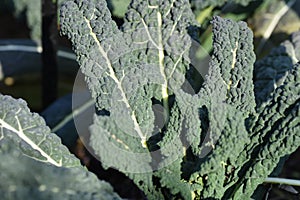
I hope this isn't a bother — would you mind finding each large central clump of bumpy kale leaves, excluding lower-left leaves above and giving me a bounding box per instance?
[60,0,300,199]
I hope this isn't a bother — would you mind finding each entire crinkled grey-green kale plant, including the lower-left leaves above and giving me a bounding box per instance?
[0,0,300,199]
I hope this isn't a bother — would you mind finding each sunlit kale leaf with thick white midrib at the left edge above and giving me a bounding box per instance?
[0,94,80,167]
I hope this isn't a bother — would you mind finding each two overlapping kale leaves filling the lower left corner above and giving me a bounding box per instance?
[0,94,120,200]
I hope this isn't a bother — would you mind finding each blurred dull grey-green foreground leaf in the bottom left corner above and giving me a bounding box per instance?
[0,138,121,200]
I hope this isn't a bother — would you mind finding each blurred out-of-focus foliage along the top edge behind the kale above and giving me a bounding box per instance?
[0,0,300,52]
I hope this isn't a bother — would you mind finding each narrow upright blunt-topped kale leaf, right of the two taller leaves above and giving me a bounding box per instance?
[208,17,255,117]
